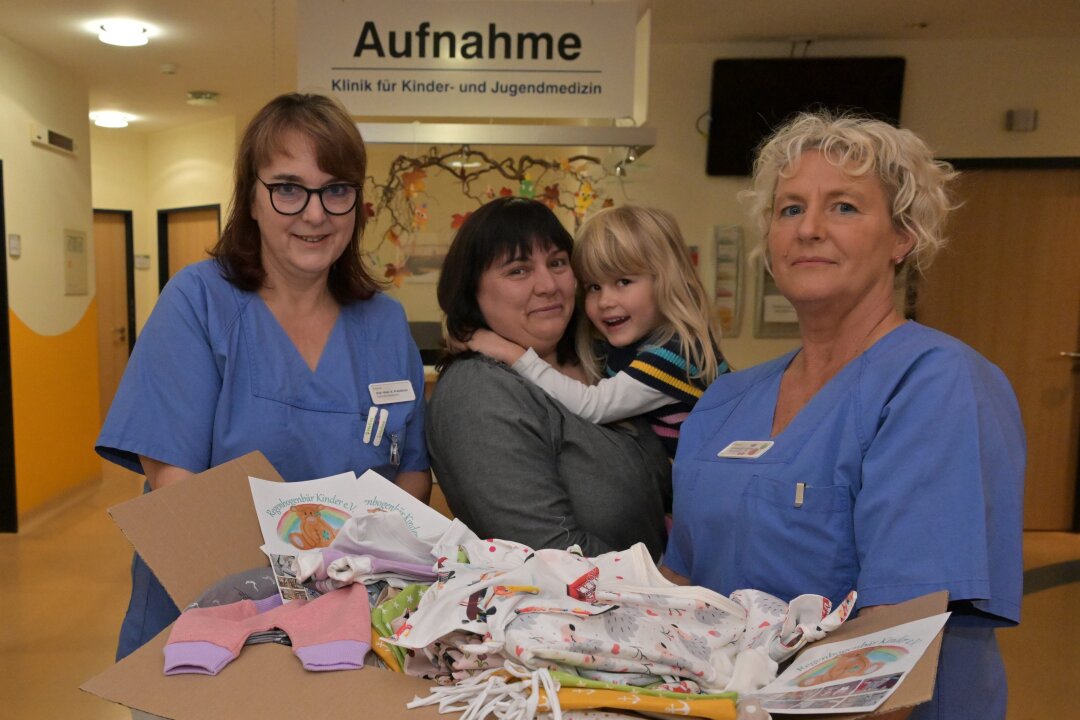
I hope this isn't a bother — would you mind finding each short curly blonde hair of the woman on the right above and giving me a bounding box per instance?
[740,111,958,272]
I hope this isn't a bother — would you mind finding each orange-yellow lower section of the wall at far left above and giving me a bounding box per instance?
[9,300,102,518]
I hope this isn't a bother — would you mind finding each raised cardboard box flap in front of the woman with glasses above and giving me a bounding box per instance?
[109,452,282,608]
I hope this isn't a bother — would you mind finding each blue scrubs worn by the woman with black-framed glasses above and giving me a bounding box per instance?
[96,260,429,657]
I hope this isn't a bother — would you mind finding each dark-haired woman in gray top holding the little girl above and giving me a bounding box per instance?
[427,198,671,557]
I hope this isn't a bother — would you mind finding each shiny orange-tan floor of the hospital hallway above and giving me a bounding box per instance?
[0,466,1080,720]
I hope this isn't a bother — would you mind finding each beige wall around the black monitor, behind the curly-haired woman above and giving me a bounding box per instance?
[630,39,1080,367]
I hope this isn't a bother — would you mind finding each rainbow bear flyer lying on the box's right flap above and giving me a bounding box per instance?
[757,612,949,715]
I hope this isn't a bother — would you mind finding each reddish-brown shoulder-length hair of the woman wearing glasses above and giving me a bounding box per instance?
[211,93,380,304]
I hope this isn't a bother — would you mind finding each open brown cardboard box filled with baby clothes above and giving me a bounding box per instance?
[81,452,946,720]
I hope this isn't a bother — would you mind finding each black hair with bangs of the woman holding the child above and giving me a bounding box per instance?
[437,198,578,370]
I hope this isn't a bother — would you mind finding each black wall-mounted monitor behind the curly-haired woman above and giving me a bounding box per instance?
[705,57,904,175]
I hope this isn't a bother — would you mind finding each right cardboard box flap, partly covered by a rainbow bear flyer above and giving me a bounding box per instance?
[772,590,948,720]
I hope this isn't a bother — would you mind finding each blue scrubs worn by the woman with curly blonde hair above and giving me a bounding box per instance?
[664,323,1026,718]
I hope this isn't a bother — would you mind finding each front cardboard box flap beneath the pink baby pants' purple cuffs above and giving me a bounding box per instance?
[81,621,447,720]
